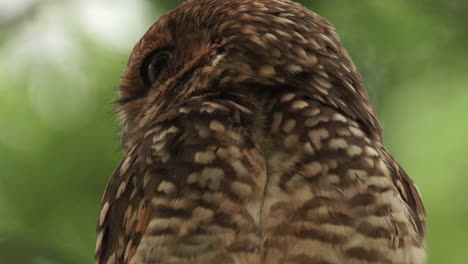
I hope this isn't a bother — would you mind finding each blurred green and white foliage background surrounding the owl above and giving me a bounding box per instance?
[0,0,468,264]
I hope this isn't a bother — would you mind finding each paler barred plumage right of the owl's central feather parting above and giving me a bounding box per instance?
[247,93,425,264]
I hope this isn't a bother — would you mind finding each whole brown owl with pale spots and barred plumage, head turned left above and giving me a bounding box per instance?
[96,0,426,264]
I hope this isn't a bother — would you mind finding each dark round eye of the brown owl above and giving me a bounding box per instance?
[141,51,171,85]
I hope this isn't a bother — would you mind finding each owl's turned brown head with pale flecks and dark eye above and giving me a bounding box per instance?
[117,0,379,152]
